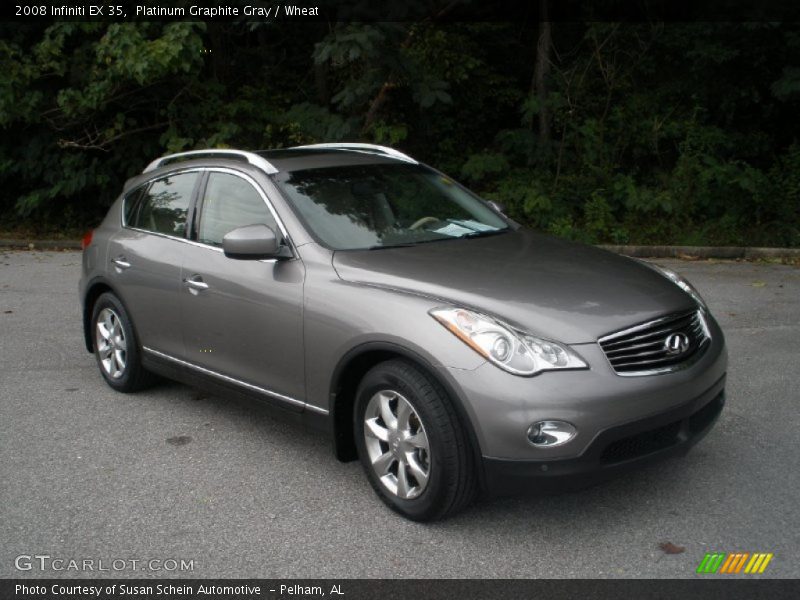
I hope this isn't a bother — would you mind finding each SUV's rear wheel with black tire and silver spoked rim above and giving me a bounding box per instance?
[91,292,156,392]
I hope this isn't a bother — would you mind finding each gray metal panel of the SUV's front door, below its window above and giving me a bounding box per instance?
[179,238,305,399]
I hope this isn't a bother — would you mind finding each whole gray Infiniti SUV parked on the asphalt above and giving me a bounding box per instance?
[80,144,727,521]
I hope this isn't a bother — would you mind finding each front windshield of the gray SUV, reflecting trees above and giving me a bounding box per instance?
[276,163,508,250]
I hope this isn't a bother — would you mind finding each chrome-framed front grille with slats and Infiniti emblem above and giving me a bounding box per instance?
[599,310,709,375]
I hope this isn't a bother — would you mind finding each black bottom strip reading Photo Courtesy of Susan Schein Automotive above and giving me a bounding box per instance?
[0,576,800,600]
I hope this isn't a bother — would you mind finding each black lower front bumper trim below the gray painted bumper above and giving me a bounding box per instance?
[483,377,725,495]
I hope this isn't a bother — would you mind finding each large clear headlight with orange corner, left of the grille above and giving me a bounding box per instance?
[430,308,588,375]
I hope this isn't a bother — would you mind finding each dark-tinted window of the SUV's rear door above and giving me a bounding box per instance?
[126,173,198,237]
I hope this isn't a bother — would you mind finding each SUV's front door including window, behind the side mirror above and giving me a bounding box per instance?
[180,169,305,410]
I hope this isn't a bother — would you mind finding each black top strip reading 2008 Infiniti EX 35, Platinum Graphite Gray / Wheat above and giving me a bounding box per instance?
[0,0,800,23]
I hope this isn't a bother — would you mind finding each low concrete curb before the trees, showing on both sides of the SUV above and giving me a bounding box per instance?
[0,239,800,260]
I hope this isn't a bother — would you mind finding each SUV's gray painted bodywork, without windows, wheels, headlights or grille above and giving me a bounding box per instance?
[80,152,727,459]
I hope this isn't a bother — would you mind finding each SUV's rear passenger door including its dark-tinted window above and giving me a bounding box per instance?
[107,171,200,357]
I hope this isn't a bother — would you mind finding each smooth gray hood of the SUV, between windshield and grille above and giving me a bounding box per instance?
[333,229,695,344]
